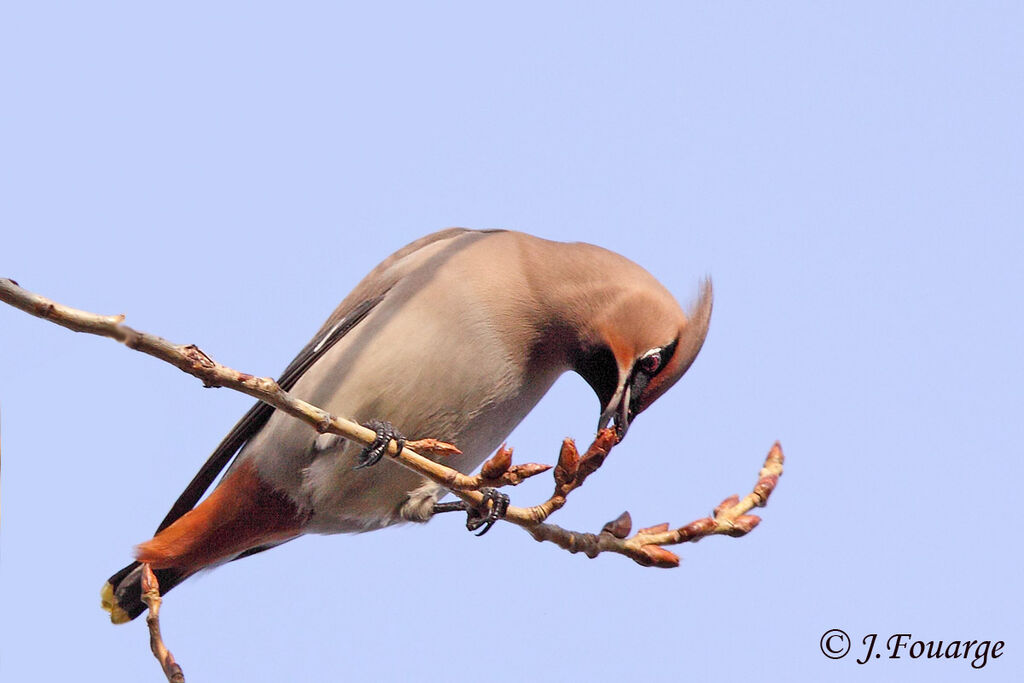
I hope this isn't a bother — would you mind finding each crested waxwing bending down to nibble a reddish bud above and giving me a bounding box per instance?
[101,228,713,624]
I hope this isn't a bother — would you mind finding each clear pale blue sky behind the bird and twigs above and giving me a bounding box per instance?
[0,2,1024,682]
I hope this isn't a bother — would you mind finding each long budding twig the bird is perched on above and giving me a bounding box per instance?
[0,279,782,567]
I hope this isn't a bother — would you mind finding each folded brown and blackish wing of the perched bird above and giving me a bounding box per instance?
[157,227,490,532]
